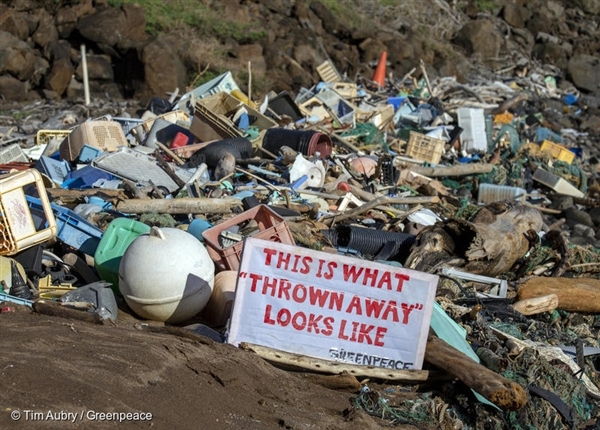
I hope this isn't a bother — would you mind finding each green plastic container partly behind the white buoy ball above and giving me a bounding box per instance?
[94,218,150,295]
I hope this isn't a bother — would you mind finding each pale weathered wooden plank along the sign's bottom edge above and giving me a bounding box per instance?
[240,342,429,382]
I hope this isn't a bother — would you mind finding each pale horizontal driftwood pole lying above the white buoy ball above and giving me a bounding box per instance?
[116,197,242,215]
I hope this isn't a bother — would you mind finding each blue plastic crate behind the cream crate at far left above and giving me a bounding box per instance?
[26,196,104,255]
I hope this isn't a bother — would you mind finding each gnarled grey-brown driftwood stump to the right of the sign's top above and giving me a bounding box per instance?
[405,204,543,276]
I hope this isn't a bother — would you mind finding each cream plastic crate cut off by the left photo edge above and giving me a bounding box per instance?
[0,169,57,255]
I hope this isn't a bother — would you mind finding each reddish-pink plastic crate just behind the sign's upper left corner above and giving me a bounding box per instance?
[202,205,296,270]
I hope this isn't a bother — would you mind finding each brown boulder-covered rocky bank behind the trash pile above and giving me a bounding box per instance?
[0,0,600,101]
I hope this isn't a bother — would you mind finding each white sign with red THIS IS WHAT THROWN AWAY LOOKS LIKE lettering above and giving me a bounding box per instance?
[227,238,438,369]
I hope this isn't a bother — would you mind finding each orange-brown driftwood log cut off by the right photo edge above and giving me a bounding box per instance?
[517,276,600,313]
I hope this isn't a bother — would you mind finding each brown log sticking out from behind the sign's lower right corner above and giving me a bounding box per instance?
[425,334,527,411]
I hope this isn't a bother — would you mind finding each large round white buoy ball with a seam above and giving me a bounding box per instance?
[119,227,215,323]
